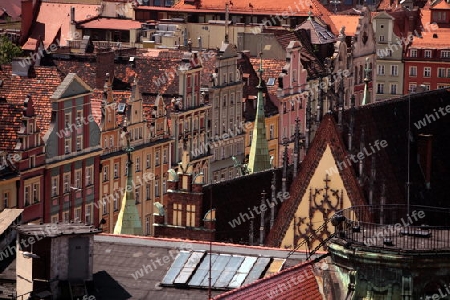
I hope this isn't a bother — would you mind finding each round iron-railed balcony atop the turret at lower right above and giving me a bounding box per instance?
[331,205,450,252]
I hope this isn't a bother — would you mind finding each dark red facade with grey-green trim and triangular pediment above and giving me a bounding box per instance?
[43,73,101,225]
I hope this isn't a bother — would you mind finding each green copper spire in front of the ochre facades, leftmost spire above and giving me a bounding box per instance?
[114,127,142,235]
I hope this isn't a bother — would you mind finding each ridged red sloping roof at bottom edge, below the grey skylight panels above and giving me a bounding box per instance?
[213,261,323,300]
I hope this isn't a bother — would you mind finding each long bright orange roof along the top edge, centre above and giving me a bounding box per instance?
[173,0,323,16]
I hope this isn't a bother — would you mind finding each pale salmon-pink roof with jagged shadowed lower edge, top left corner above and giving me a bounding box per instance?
[22,2,101,50]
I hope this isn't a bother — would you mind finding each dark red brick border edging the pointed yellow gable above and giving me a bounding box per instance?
[266,115,366,247]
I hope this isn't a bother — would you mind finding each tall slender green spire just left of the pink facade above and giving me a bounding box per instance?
[248,48,271,173]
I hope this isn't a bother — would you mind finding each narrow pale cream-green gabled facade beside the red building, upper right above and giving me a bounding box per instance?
[372,12,404,100]
